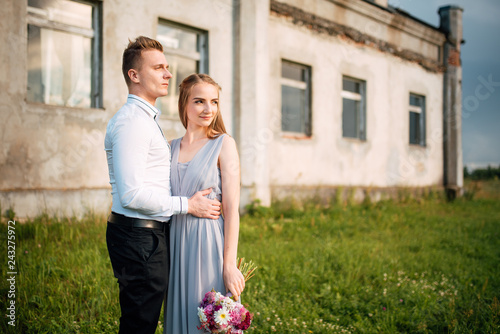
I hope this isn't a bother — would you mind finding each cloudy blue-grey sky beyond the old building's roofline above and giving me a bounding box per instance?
[389,0,500,170]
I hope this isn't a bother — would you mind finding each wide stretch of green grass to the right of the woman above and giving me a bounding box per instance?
[240,194,500,333]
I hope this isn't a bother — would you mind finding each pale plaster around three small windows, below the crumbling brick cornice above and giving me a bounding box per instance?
[269,17,443,187]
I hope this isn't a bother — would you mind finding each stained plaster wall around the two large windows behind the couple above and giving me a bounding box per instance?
[0,0,233,217]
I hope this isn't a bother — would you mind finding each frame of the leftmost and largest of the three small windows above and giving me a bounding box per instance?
[280,59,312,138]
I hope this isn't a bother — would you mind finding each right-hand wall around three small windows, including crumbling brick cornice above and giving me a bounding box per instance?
[269,0,444,197]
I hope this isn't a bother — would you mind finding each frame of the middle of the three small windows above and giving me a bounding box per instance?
[340,75,367,141]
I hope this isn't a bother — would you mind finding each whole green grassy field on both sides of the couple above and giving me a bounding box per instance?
[0,181,500,333]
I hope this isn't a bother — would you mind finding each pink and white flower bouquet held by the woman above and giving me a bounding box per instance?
[198,259,257,334]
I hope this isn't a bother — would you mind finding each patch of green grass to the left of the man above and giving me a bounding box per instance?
[0,215,119,333]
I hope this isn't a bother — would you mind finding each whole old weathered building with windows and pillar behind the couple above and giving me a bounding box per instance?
[0,0,462,217]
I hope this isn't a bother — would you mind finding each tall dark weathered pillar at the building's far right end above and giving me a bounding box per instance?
[438,6,463,200]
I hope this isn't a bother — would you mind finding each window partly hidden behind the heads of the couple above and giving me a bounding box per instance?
[156,20,208,118]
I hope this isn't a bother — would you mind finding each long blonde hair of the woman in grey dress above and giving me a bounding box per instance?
[179,73,227,139]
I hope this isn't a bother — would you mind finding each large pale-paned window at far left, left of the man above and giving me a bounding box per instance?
[27,0,102,108]
